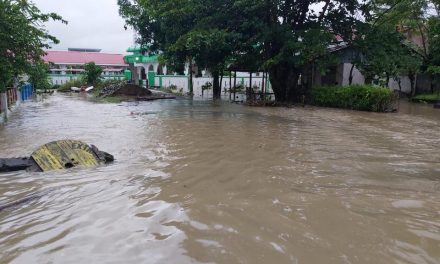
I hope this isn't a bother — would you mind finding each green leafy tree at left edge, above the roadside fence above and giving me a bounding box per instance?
[0,0,67,91]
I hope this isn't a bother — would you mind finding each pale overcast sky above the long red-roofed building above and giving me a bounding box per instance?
[32,0,133,53]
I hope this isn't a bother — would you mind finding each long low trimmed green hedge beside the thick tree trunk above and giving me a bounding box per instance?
[310,85,396,112]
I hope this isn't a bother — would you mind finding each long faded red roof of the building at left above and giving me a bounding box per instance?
[43,50,125,65]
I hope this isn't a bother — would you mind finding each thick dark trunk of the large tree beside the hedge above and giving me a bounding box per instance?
[269,64,301,103]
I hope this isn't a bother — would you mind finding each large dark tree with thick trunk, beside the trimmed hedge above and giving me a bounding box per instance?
[256,0,360,101]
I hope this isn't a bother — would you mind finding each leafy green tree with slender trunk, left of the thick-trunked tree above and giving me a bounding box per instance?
[118,0,241,99]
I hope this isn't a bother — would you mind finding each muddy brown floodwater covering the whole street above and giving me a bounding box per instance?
[0,95,440,264]
